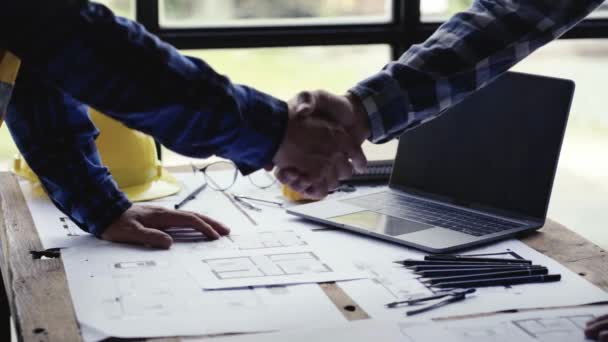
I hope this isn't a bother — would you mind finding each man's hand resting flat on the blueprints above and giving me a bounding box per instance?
[101,205,230,249]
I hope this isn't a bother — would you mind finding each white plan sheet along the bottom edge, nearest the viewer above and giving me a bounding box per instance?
[205,306,608,342]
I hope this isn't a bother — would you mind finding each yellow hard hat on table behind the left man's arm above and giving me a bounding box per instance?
[13,109,181,202]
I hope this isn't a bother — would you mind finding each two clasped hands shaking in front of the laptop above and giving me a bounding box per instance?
[267,91,370,199]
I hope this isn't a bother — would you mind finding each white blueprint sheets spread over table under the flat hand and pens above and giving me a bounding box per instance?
[16,174,608,341]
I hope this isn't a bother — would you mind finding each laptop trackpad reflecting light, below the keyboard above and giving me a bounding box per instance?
[327,211,434,236]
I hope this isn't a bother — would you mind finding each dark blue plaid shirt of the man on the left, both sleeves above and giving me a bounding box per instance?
[0,2,288,236]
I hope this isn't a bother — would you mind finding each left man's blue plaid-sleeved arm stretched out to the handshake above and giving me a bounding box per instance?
[6,4,287,172]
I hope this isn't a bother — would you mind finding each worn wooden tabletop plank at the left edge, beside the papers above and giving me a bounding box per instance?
[0,173,82,341]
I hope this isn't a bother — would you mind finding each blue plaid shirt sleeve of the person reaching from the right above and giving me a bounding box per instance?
[350,0,603,143]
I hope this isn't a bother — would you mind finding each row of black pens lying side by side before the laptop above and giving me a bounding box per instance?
[396,255,561,289]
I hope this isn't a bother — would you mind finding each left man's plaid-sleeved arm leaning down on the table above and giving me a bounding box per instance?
[6,68,131,236]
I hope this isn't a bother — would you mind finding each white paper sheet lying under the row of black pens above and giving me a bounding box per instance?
[309,231,608,320]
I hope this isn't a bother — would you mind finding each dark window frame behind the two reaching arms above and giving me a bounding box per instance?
[135,0,608,59]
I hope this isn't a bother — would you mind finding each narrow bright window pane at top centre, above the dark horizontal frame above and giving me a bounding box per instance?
[159,0,392,28]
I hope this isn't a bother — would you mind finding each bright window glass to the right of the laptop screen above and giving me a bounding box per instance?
[515,39,608,248]
